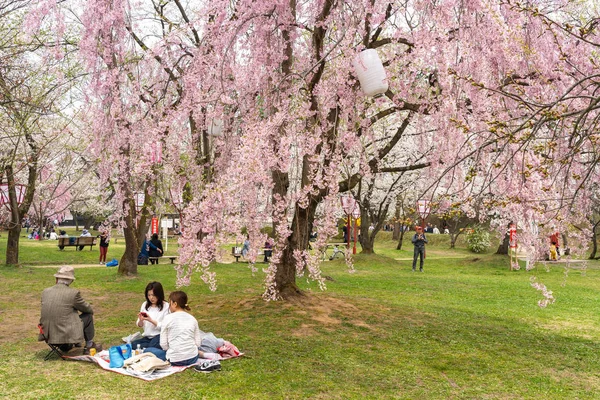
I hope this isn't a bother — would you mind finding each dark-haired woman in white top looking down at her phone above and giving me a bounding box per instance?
[131,282,169,349]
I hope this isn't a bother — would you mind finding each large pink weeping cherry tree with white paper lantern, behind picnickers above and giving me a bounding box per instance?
[105,1,593,299]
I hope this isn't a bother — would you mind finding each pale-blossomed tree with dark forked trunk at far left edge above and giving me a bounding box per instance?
[0,0,81,265]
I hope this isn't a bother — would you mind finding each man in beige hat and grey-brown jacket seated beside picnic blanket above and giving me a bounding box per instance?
[40,265,102,354]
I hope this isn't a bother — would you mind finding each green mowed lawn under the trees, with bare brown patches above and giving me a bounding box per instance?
[0,233,600,399]
